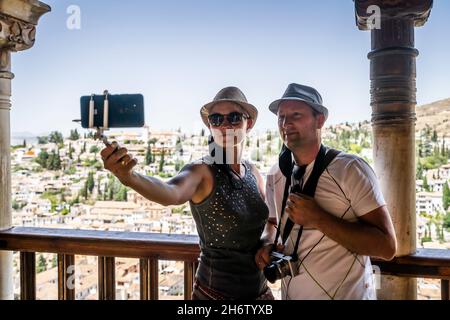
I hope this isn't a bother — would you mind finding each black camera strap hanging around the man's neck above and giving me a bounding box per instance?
[274,145,340,260]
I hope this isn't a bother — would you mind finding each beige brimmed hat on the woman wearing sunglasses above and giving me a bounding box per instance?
[200,87,258,127]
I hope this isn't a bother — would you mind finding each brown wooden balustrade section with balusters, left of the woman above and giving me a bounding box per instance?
[0,227,200,300]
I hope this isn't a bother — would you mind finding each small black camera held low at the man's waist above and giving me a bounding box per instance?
[264,251,298,283]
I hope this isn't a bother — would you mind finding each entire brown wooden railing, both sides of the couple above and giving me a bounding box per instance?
[0,227,450,300]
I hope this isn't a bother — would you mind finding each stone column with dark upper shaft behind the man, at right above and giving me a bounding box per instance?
[355,0,433,300]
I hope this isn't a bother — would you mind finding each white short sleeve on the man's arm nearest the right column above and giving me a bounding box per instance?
[343,157,386,217]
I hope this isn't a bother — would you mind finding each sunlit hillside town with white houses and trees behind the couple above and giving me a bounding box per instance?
[11,112,450,300]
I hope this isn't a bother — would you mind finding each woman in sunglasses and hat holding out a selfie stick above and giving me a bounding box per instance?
[101,87,273,300]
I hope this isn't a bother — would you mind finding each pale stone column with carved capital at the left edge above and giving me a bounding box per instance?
[0,0,50,300]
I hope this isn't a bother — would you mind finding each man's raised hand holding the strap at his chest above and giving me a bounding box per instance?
[285,193,327,229]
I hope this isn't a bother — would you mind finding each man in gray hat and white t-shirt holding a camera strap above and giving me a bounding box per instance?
[255,84,397,299]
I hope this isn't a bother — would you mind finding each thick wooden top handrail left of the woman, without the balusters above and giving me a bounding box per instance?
[0,227,200,261]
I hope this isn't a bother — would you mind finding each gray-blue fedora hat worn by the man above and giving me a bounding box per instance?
[269,83,328,120]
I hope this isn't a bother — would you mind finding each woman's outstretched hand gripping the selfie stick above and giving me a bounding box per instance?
[100,141,137,185]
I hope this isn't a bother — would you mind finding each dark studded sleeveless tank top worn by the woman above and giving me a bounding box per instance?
[190,156,269,299]
